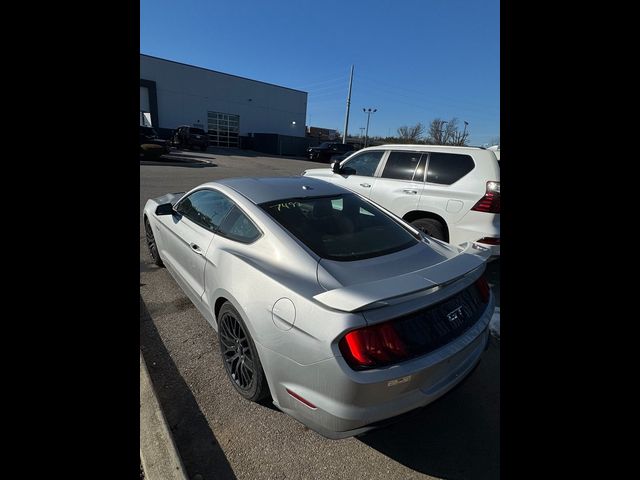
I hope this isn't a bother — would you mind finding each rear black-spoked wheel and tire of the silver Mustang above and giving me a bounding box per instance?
[218,302,269,402]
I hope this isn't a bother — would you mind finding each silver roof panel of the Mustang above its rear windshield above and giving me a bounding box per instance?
[214,176,350,204]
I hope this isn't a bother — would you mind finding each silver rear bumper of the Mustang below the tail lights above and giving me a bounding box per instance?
[258,295,494,439]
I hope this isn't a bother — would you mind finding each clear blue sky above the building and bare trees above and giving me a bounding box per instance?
[140,0,500,145]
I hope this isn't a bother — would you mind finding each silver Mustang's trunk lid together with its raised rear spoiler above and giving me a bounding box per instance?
[313,243,488,312]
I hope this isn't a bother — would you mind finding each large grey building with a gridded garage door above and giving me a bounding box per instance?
[140,54,307,147]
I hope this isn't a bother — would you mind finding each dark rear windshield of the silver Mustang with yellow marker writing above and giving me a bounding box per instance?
[260,193,418,261]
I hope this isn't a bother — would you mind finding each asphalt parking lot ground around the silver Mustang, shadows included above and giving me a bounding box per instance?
[139,149,500,480]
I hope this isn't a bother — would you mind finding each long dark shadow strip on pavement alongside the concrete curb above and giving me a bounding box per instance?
[140,297,236,480]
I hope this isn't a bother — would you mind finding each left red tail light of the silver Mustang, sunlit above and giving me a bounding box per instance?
[339,322,407,370]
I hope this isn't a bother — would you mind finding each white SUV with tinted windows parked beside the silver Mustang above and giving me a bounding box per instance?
[303,145,500,256]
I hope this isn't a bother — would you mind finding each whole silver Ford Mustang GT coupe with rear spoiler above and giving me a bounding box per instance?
[143,177,494,438]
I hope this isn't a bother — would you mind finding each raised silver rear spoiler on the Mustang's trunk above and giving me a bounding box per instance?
[313,242,489,312]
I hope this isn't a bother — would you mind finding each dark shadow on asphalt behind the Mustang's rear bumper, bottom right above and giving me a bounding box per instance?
[358,338,500,480]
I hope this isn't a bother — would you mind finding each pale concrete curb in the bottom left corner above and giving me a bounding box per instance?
[140,352,188,480]
